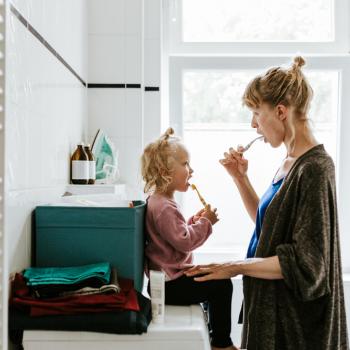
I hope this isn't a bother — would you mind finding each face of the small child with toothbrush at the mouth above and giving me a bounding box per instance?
[168,146,193,192]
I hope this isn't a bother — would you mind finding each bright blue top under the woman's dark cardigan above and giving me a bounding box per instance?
[247,178,284,258]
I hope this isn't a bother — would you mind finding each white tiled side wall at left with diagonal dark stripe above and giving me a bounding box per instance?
[5,0,87,278]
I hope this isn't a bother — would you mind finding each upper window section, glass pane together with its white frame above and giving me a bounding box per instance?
[166,0,349,55]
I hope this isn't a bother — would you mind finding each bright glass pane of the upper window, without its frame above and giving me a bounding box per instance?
[182,0,334,42]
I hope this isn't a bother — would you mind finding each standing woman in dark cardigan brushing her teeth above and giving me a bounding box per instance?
[187,57,348,350]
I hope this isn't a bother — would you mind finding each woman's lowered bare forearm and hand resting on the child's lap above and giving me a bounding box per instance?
[185,256,283,282]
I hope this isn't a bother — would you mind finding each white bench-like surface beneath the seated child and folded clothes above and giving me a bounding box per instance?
[23,305,211,350]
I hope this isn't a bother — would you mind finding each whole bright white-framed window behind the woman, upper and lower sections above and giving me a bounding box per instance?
[165,0,350,271]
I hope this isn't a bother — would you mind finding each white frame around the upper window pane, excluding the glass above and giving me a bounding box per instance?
[165,0,350,55]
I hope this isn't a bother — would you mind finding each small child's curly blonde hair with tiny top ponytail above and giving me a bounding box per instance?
[141,128,184,193]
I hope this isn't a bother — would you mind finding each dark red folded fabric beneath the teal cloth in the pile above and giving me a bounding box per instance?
[10,274,140,316]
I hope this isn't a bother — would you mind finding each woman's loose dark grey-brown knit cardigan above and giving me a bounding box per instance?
[242,145,348,350]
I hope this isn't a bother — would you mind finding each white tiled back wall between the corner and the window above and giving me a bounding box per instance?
[88,0,161,198]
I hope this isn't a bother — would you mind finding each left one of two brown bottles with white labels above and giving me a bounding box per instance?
[71,142,89,185]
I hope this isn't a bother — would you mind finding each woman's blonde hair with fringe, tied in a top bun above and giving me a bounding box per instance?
[242,56,313,117]
